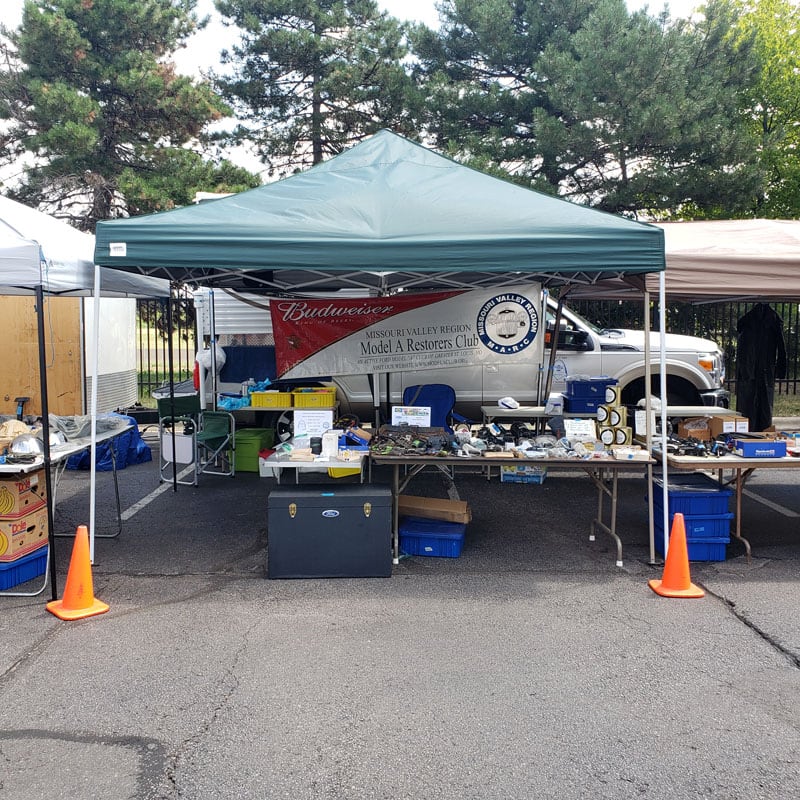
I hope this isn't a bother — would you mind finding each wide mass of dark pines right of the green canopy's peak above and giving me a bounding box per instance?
[414,0,759,216]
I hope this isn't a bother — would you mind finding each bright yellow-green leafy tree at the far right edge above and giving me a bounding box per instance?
[733,0,800,219]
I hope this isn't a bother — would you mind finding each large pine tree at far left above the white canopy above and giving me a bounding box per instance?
[0,0,254,230]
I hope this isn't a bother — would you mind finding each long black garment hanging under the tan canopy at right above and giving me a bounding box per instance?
[736,303,786,431]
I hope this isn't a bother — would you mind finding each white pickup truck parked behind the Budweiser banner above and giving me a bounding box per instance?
[203,297,730,419]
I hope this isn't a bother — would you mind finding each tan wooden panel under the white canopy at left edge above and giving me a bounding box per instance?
[0,296,83,416]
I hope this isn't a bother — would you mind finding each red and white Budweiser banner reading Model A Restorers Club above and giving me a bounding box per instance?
[270,284,544,378]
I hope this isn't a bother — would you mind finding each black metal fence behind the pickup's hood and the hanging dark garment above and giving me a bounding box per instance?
[568,300,800,395]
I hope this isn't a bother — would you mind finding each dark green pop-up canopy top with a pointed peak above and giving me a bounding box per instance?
[95,130,666,564]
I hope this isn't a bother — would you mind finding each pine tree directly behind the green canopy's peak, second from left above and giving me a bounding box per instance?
[216,0,416,174]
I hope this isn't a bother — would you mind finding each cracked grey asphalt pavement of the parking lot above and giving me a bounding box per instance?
[0,428,800,800]
